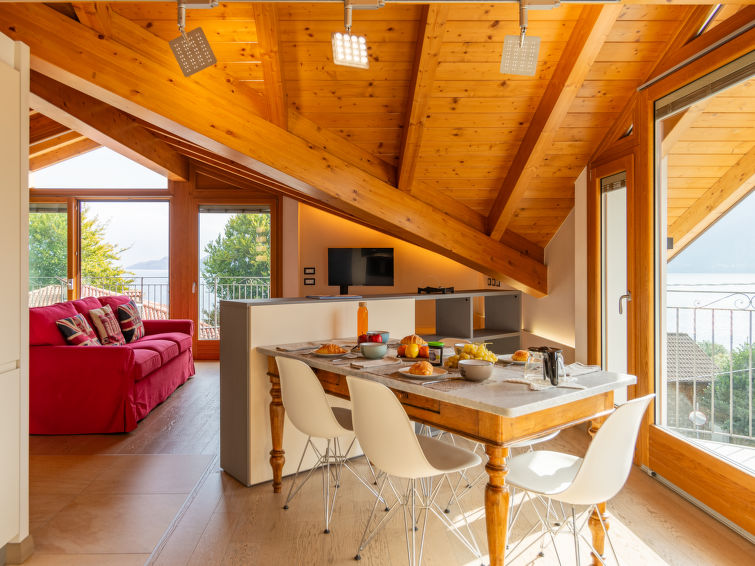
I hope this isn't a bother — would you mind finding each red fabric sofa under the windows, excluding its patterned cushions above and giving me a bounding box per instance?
[29,296,194,434]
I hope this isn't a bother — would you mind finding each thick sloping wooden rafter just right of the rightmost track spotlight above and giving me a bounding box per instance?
[488,5,621,240]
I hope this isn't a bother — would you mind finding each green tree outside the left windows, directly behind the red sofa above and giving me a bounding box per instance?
[29,207,133,287]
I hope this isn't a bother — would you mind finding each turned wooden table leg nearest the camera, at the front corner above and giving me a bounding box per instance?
[485,444,510,566]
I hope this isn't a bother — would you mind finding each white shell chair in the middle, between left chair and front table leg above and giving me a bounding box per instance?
[346,376,481,566]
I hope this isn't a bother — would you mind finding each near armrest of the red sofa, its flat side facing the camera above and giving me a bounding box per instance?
[29,346,136,434]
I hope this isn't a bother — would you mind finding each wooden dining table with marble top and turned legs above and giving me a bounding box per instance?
[256,340,636,566]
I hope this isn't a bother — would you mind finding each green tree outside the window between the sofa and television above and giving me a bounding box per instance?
[202,213,270,324]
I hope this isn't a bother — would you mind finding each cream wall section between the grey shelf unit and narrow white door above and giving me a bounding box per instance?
[522,211,575,348]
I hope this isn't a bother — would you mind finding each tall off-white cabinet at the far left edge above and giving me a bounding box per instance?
[0,34,29,547]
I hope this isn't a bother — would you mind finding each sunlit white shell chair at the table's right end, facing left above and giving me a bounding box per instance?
[506,395,655,566]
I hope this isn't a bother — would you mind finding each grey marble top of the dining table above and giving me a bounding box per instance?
[256,340,637,418]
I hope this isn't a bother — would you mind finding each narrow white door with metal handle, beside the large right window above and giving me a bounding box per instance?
[600,171,631,403]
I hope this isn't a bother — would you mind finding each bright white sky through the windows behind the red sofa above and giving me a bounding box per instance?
[29,148,233,267]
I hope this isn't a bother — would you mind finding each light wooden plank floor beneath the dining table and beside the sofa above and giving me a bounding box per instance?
[31,362,755,566]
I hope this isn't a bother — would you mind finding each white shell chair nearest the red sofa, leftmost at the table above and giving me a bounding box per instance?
[275,356,376,533]
